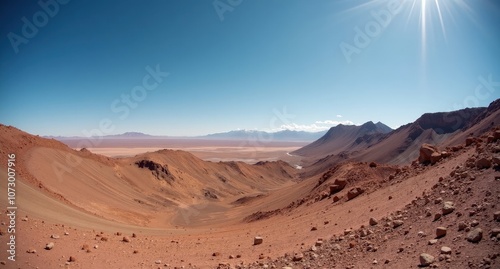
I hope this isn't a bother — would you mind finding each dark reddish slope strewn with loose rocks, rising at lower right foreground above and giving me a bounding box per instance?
[217,129,500,269]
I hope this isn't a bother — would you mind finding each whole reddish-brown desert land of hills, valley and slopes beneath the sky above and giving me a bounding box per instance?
[0,100,500,268]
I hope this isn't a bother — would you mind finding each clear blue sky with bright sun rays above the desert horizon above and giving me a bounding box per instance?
[0,0,500,136]
